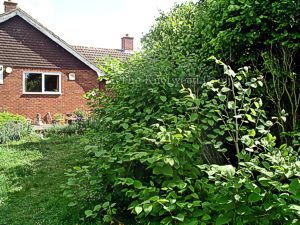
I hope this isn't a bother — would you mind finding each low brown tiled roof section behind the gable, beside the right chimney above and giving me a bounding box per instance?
[72,46,132,65]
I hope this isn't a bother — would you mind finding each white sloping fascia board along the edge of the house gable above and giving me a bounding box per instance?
[0,8,105,77]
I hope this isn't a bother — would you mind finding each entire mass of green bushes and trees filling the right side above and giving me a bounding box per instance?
[64,0,300,222]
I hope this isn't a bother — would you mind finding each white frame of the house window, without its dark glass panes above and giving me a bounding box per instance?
[23,71,62,95]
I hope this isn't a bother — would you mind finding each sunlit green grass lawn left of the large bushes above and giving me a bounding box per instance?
[0,136,85,225]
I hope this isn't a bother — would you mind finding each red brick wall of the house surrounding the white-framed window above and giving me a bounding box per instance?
[0,68,99,119]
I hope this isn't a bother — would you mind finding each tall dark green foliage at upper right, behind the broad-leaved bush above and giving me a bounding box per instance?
[141,0,300,134]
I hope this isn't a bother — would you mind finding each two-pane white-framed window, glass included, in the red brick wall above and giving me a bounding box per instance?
[23,72,61,94]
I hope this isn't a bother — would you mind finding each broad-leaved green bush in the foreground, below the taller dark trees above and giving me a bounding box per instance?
[64,60,300,225]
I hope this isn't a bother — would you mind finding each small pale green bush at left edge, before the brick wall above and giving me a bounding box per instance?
[0,112,32,143]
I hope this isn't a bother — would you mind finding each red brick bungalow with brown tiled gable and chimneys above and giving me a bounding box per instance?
[0,0,133,122]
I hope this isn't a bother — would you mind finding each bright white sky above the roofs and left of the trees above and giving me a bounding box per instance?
[5,0,195,49]
